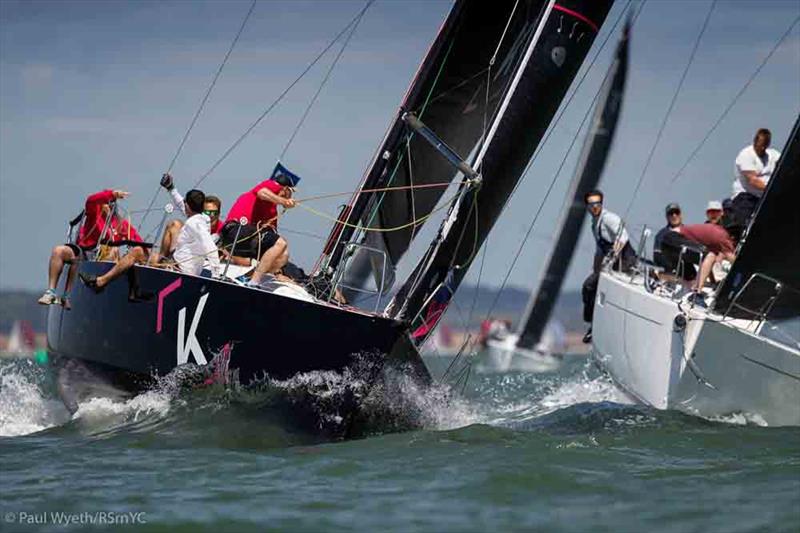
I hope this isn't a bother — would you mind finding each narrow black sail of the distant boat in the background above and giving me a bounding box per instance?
[517,19,630,350]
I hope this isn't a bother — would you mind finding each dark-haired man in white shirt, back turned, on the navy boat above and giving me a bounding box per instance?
[172,189,220,277]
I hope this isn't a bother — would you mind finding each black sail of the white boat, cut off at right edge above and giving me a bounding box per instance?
[714,117,800,318]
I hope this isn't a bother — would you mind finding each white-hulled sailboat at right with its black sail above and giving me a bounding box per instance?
[593,117,800,426]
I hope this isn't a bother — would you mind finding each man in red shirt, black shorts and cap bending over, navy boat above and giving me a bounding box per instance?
[220,173,297,283]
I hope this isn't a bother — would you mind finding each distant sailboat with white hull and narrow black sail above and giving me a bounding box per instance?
[485,19,630,372]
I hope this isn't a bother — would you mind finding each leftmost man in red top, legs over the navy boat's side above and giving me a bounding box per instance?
[39,189,144,309]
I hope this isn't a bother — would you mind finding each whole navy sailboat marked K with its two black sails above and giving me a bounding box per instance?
[47,0,612,426]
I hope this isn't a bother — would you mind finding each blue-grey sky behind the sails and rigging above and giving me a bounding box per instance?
[0,0,800,296]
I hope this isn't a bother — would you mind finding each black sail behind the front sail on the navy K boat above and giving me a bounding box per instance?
[321,0,560,296]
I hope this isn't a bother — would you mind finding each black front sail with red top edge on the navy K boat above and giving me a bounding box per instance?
[387,0,612,343]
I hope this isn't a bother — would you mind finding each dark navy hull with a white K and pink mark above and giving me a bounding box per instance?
[47,262,429,412]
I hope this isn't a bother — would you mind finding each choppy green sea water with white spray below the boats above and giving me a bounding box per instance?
[0,356,800,532]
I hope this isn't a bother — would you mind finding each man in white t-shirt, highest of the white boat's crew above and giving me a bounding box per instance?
[731,128,781,226]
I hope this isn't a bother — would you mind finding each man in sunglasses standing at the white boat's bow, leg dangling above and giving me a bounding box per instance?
[581,189,636,344]
